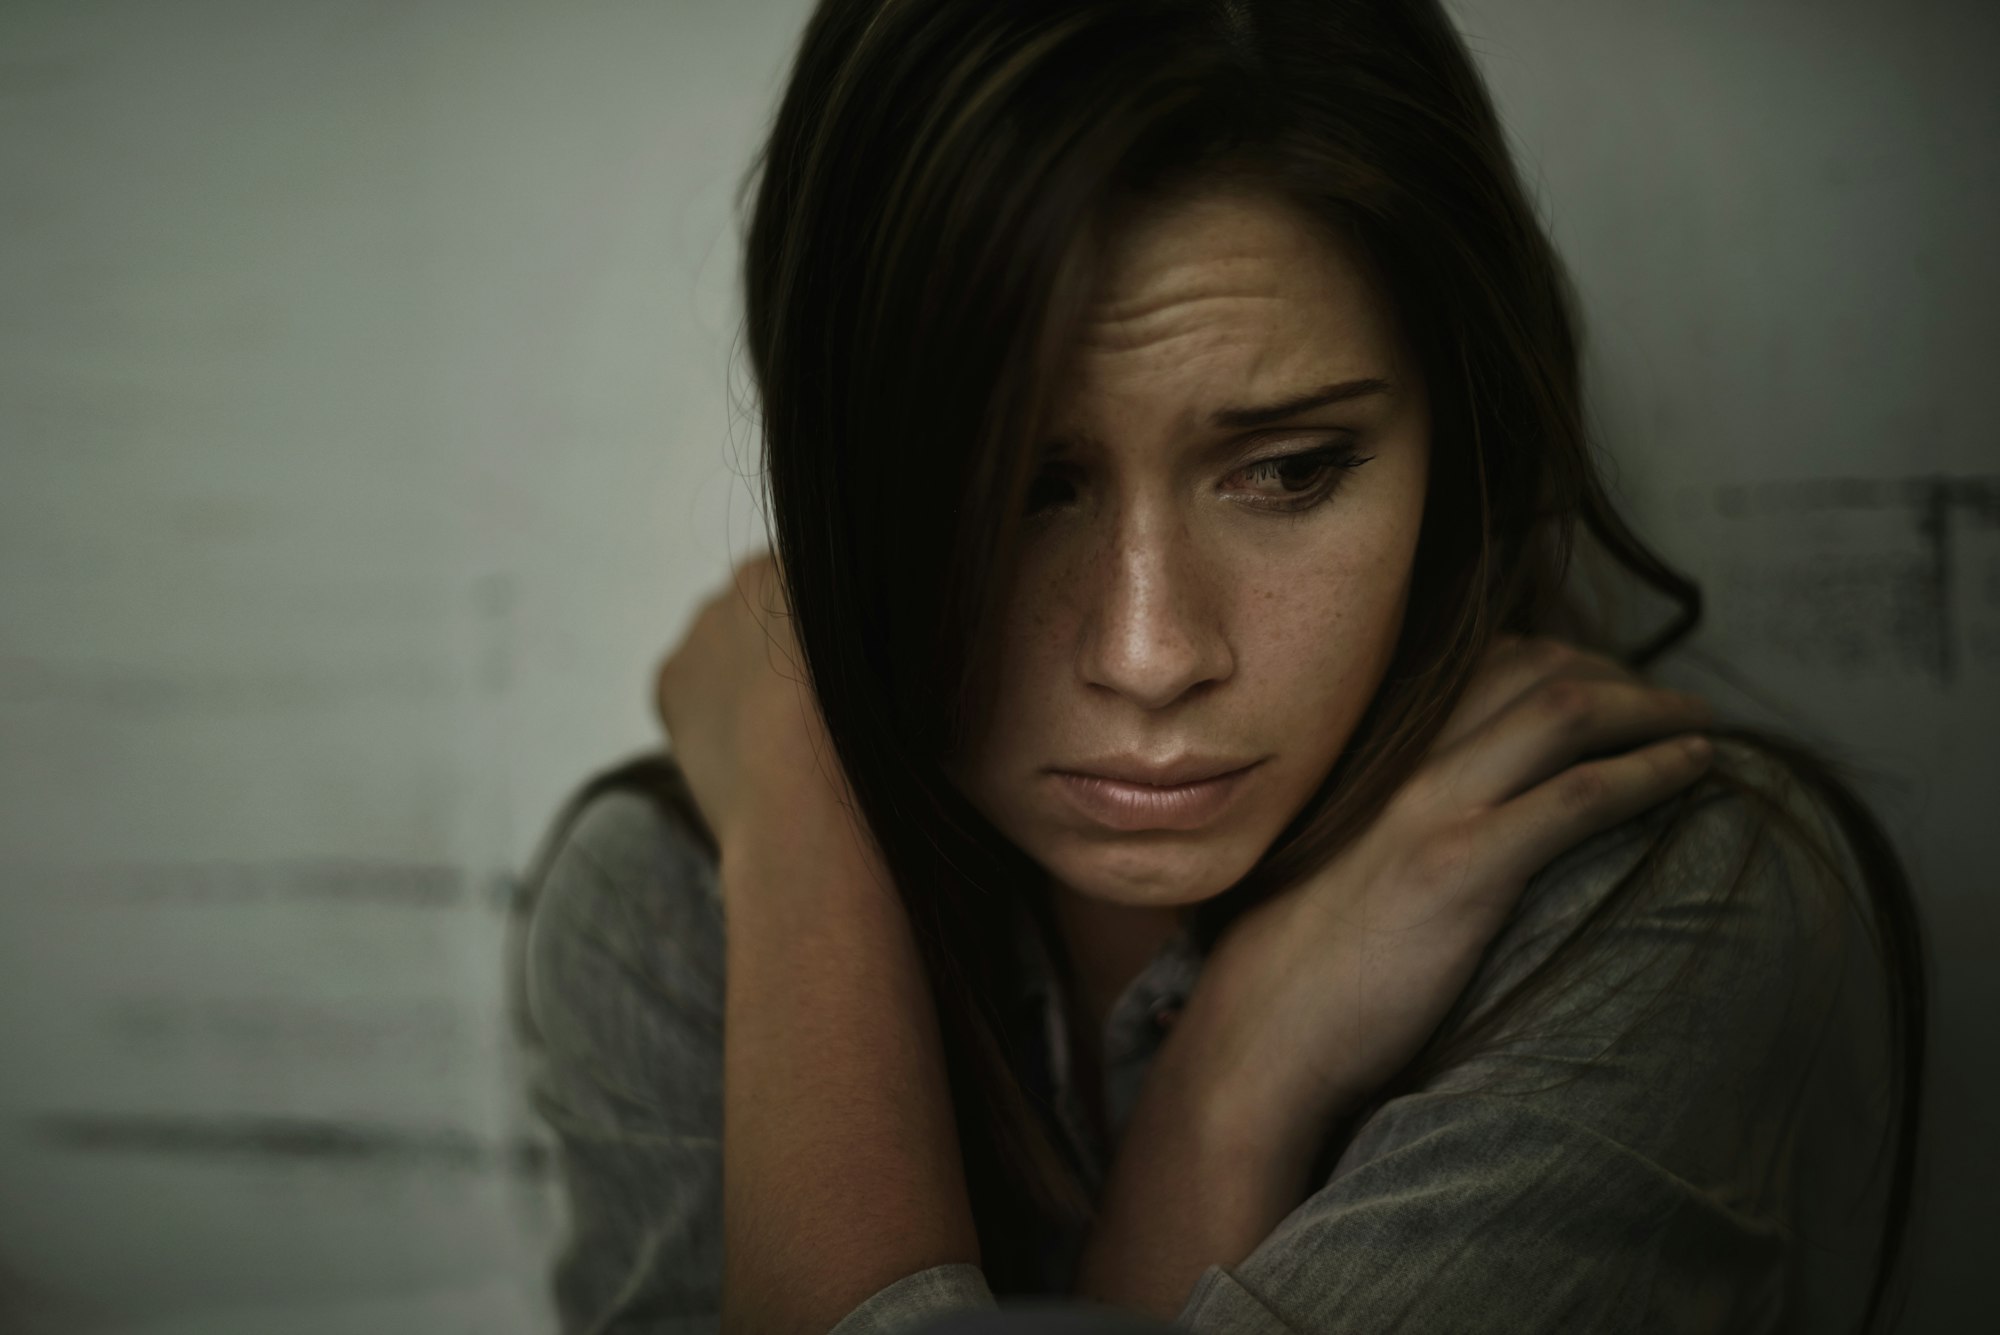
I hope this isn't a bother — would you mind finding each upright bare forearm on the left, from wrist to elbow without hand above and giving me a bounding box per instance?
[722,783,978,1335]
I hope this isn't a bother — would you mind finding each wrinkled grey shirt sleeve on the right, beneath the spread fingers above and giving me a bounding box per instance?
[1178,743,1866,1335]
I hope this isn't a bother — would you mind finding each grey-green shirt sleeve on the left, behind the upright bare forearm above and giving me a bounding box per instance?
[524,775,724,1335]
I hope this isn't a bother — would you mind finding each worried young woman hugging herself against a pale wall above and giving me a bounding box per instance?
[524,0,1926,1335]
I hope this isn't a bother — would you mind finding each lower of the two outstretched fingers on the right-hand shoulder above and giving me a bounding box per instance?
[1480,733,1714,883]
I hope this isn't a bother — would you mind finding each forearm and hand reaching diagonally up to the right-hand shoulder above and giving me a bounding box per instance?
[1078,642,1706,1317]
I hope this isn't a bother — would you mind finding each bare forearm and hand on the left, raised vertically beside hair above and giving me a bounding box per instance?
[656,558,992,1335]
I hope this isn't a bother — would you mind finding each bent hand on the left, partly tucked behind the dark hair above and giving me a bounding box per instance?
[654,554,848,845]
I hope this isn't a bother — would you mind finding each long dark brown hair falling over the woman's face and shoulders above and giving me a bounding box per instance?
[744,0,1926,1327]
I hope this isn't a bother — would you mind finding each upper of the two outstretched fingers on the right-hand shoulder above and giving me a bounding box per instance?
[1440,675,1712,805]
